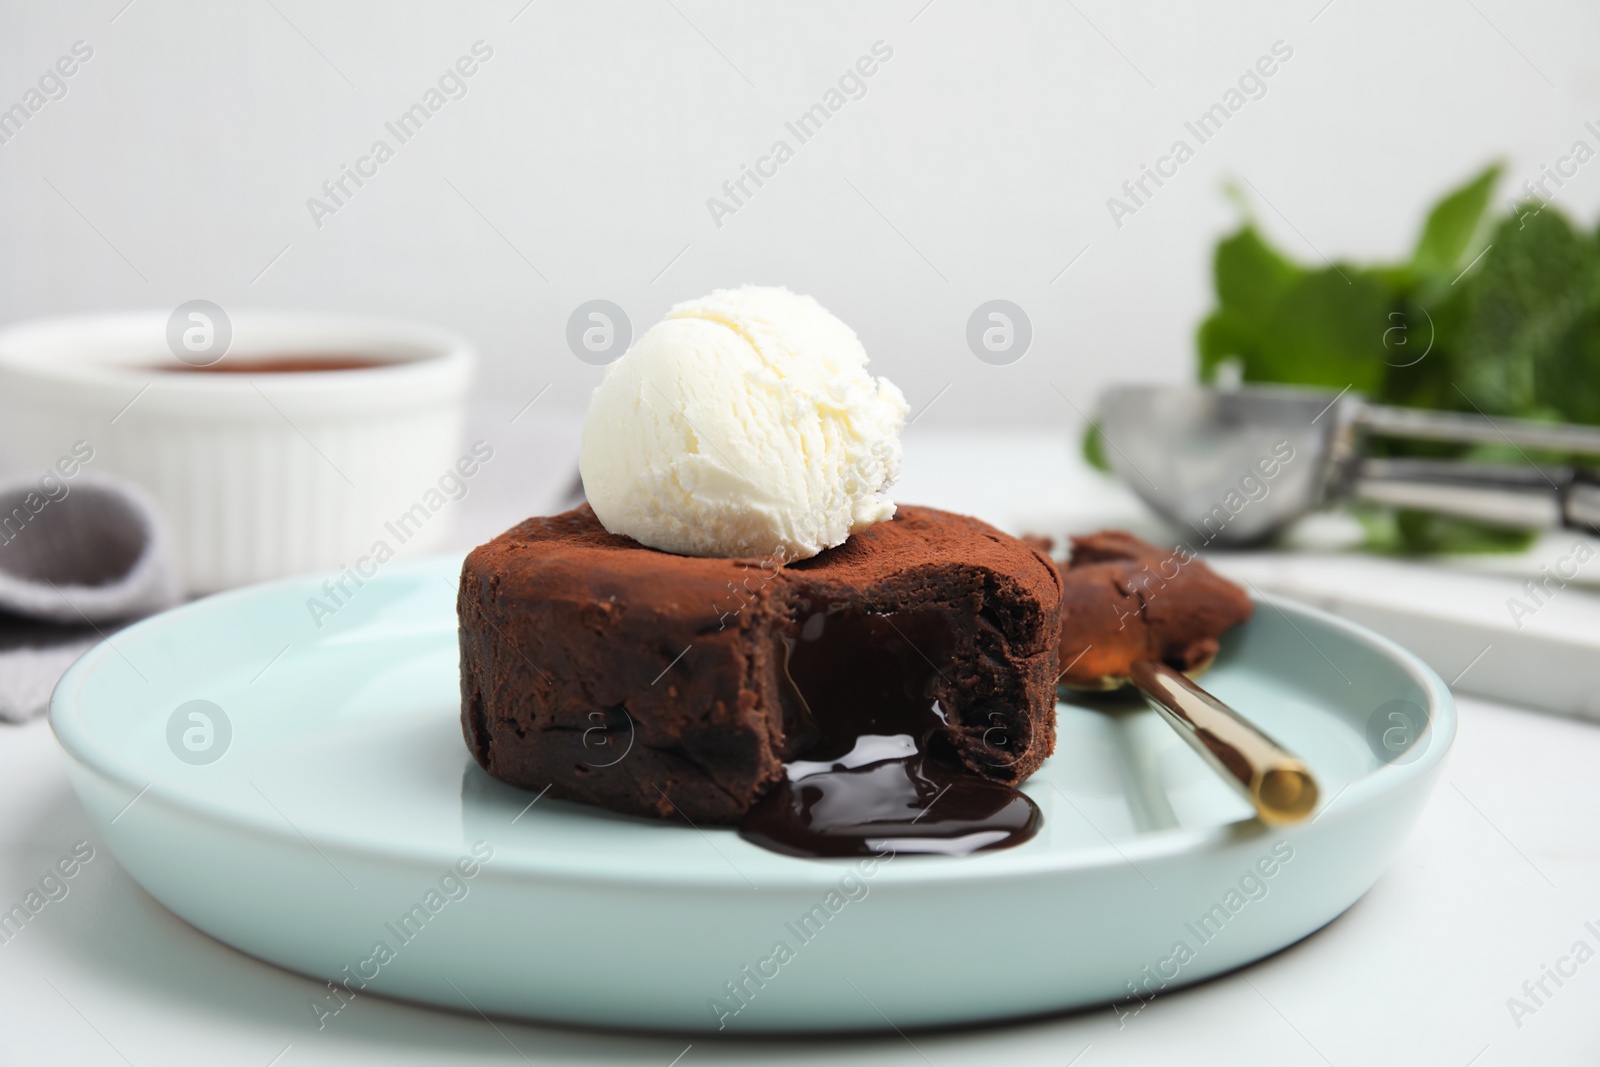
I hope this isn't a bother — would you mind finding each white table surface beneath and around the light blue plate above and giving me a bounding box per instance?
[9,422,1600,1067]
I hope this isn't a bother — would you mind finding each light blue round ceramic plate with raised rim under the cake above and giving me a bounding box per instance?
[51,558,1456,1032]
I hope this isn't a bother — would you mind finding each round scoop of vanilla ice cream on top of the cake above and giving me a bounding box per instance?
[579,285,907,561]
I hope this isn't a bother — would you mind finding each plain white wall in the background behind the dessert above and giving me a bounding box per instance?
[0,0,1600,424]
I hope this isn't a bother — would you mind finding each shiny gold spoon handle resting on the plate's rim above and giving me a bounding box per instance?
[1128,659,1317,825]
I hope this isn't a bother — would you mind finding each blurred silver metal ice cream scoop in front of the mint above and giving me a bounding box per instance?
[1096,386,1600,544]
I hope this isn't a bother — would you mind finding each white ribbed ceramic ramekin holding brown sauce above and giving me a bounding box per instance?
[0,310,477,593]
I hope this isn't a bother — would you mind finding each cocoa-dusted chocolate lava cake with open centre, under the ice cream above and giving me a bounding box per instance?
[458,506,1061,825]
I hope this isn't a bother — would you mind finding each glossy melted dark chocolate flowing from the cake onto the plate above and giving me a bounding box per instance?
[739,609,1040,856]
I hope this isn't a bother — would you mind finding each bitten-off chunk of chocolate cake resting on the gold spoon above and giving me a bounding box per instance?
[1043,530,1253,689]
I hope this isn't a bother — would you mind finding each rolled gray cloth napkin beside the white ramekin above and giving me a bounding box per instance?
[0,474,179,723]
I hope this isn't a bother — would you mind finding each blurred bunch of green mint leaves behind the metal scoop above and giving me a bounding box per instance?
[1197,165,1600,553]
